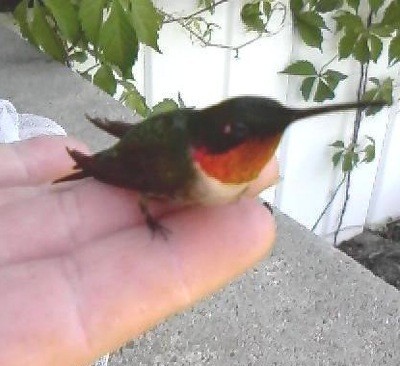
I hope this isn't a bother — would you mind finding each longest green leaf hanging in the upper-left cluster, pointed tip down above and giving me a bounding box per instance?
[99,0,138,77]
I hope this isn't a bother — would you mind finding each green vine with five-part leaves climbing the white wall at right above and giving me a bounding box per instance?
[282,0,400,243]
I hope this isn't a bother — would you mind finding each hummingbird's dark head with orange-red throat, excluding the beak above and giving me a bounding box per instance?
[189,97,293,184]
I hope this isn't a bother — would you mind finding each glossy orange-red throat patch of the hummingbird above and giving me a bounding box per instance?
[193,134,281,184]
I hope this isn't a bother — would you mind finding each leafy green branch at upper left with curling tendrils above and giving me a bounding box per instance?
[14,0,286,116]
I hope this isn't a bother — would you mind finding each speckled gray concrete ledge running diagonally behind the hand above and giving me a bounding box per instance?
[0,26,400,366]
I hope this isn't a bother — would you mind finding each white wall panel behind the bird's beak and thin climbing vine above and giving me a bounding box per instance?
[277,17,394,243]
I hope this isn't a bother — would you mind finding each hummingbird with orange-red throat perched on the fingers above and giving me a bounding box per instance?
[54,96,383,235]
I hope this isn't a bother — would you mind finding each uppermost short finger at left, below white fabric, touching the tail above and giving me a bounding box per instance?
[0,136,87,187]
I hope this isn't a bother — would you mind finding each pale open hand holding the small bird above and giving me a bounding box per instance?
[0,137,278,366]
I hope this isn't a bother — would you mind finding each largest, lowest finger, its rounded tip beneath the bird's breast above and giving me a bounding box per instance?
[0,201,274,366]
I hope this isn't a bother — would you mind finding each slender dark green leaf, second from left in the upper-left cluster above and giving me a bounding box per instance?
[31,1,66,62]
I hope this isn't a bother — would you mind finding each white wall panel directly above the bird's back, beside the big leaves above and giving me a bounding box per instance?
[146,1,233,107]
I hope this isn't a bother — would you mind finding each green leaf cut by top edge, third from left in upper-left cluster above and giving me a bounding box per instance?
[43,0,80,44]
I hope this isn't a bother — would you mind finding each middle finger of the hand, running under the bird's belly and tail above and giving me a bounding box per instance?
[0,179,173,264]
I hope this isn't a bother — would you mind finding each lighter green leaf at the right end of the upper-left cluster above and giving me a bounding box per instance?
[130,0,163,52]
